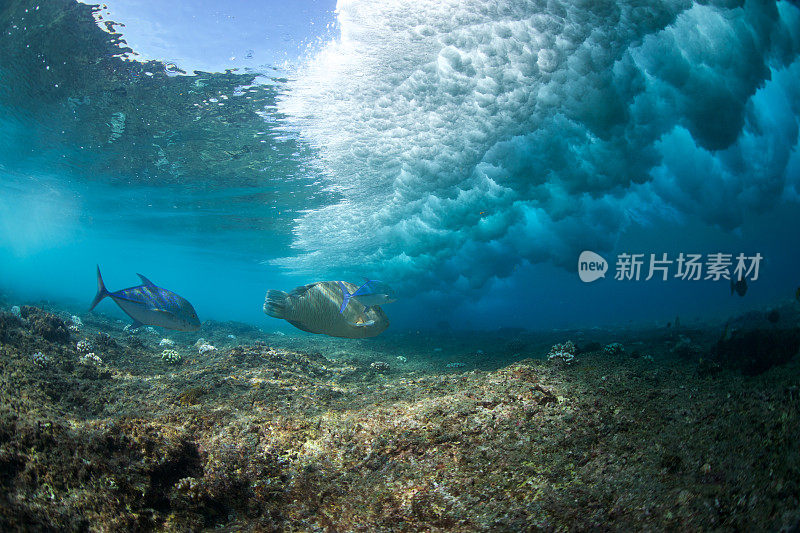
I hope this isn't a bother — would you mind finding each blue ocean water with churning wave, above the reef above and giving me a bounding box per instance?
[0,0,800,332]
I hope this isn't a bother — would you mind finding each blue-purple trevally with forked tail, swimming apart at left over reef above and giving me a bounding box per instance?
[89,266,200,331]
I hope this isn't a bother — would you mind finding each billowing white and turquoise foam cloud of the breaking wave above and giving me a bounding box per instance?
[279,0,800,288]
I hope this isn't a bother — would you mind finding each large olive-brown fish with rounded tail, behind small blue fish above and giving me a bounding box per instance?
[264,281,389,339]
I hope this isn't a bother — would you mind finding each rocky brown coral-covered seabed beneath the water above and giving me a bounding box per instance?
[0,302,800,531]
